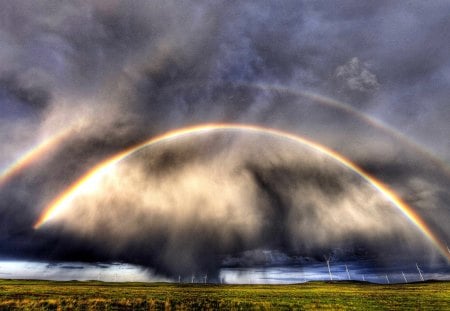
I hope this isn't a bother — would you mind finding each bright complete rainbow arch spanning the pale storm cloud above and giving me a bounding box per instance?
[34,124,450,262]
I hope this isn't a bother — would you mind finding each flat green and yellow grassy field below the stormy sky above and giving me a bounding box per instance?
[0,280,450,310]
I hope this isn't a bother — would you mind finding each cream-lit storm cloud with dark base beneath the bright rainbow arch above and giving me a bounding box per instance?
[40,131,423,275]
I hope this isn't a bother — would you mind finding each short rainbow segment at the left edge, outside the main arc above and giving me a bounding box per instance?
[0,128,71,187]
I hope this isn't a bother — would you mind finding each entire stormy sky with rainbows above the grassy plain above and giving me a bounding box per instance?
[0,0,450,282]
